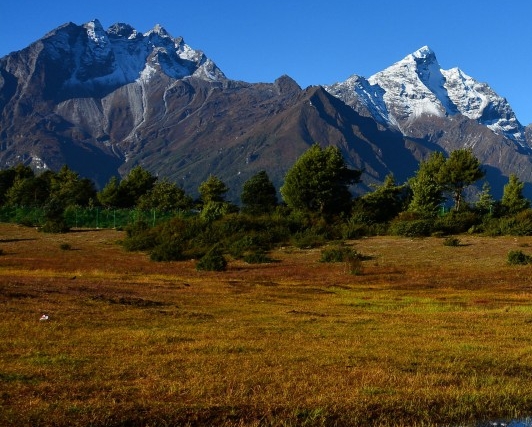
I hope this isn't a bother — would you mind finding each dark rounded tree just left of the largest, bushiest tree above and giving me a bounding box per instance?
[240,171,277,215]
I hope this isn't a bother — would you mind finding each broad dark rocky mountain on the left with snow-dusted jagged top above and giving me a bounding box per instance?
[0,20,416,201]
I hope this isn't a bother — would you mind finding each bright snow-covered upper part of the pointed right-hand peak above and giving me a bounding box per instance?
[326,46,530,149]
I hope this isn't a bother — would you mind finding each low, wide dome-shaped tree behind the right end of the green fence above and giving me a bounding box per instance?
[137,179,192,211]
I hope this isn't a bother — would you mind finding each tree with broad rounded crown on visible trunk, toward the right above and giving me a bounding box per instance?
[438,148,485,211]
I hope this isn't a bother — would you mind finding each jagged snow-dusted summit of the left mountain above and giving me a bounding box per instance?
[34,19,225,97]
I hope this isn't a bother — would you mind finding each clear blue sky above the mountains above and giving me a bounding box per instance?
[0,0,532,125]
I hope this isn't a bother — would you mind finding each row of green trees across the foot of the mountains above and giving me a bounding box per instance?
[0,144,532,237]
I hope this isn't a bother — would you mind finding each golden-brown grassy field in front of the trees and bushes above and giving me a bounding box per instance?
[0,224,532,426]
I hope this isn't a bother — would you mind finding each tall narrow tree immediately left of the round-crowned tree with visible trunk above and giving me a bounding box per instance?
[408,151,445,217]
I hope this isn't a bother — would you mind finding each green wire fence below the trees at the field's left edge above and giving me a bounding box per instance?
[0,206,183,228]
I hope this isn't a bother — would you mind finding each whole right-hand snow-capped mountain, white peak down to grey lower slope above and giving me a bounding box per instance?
[326,46,532,194]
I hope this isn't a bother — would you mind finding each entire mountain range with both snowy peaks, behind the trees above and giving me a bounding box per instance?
[0,20,532,201]
